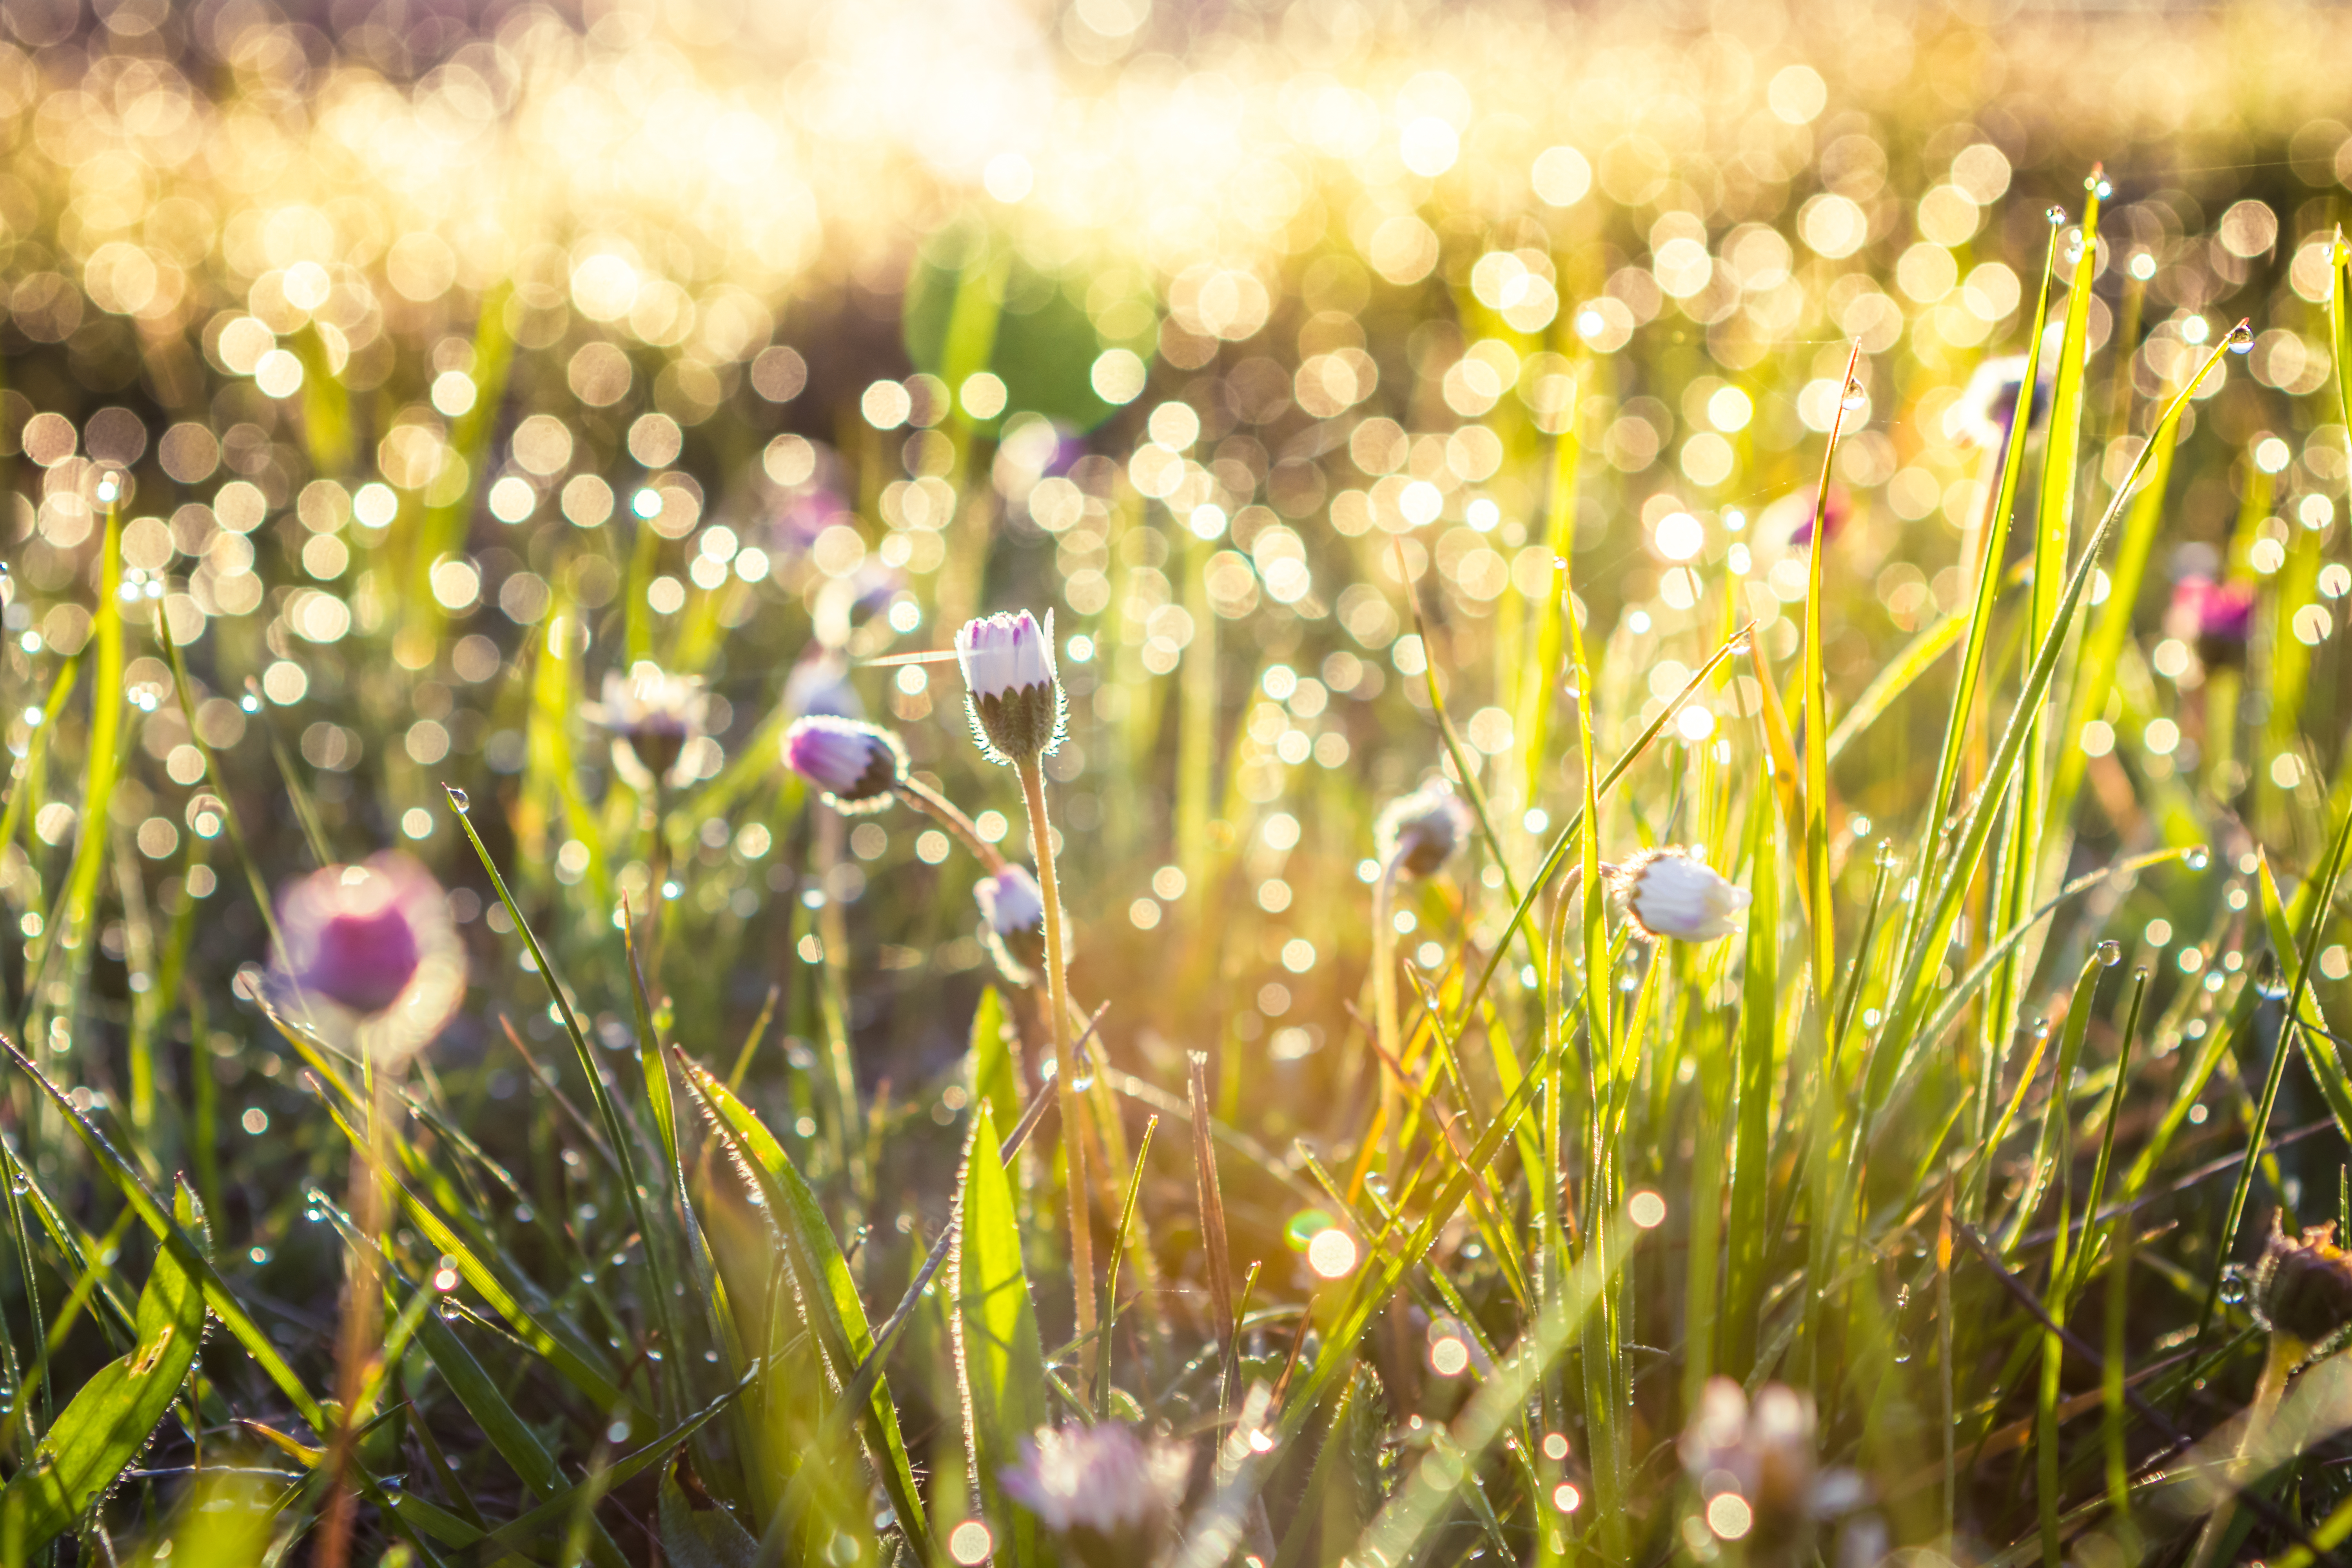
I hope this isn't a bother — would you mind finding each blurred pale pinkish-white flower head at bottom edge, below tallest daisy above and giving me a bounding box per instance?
[1004,1422,1192,1568]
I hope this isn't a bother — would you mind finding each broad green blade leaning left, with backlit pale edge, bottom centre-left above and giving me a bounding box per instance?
[675,1051,927,1540]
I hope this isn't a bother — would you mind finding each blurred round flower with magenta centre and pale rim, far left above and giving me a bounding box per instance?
[270,851,466,1063]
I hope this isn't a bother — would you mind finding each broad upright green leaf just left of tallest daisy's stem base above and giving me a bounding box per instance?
[948,1103,1047,1568]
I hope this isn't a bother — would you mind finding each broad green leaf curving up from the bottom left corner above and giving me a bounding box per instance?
[0,1182,205,1552]
